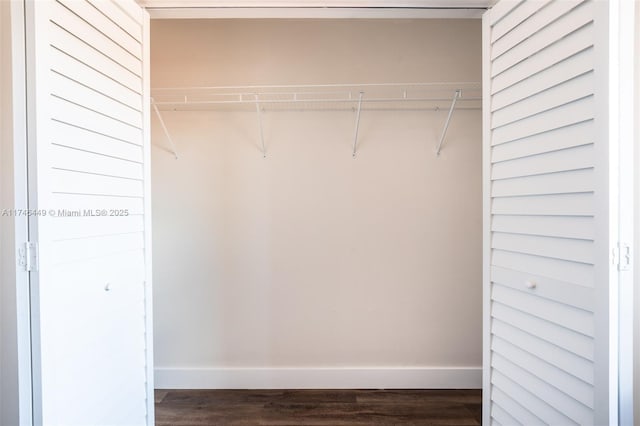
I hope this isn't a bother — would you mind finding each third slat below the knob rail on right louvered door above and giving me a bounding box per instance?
[491,319,594,384]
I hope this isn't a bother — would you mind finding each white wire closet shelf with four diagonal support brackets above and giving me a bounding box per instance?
[151,82,482,158]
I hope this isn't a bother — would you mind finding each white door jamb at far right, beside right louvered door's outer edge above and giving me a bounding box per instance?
[609,1,640,425]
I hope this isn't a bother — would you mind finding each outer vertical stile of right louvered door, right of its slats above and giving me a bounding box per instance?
[593,1,618,425]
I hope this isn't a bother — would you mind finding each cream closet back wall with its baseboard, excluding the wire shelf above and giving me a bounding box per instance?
[152,20,482,387]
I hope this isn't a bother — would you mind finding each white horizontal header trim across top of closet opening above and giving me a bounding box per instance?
[147,7,484,19]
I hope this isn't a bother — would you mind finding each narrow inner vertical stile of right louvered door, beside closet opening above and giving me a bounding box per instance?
[482,7,491,425]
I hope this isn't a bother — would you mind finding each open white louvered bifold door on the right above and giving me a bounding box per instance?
[483,0,614,426]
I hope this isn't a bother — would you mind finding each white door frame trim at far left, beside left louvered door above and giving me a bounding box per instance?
[0,0,33,426]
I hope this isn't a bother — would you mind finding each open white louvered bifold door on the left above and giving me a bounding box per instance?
[26,0,153,426]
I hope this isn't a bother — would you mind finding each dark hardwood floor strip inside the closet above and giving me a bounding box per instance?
[156,389,482,426]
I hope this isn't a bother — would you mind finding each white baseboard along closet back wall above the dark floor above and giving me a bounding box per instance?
[155,367,482,389]
